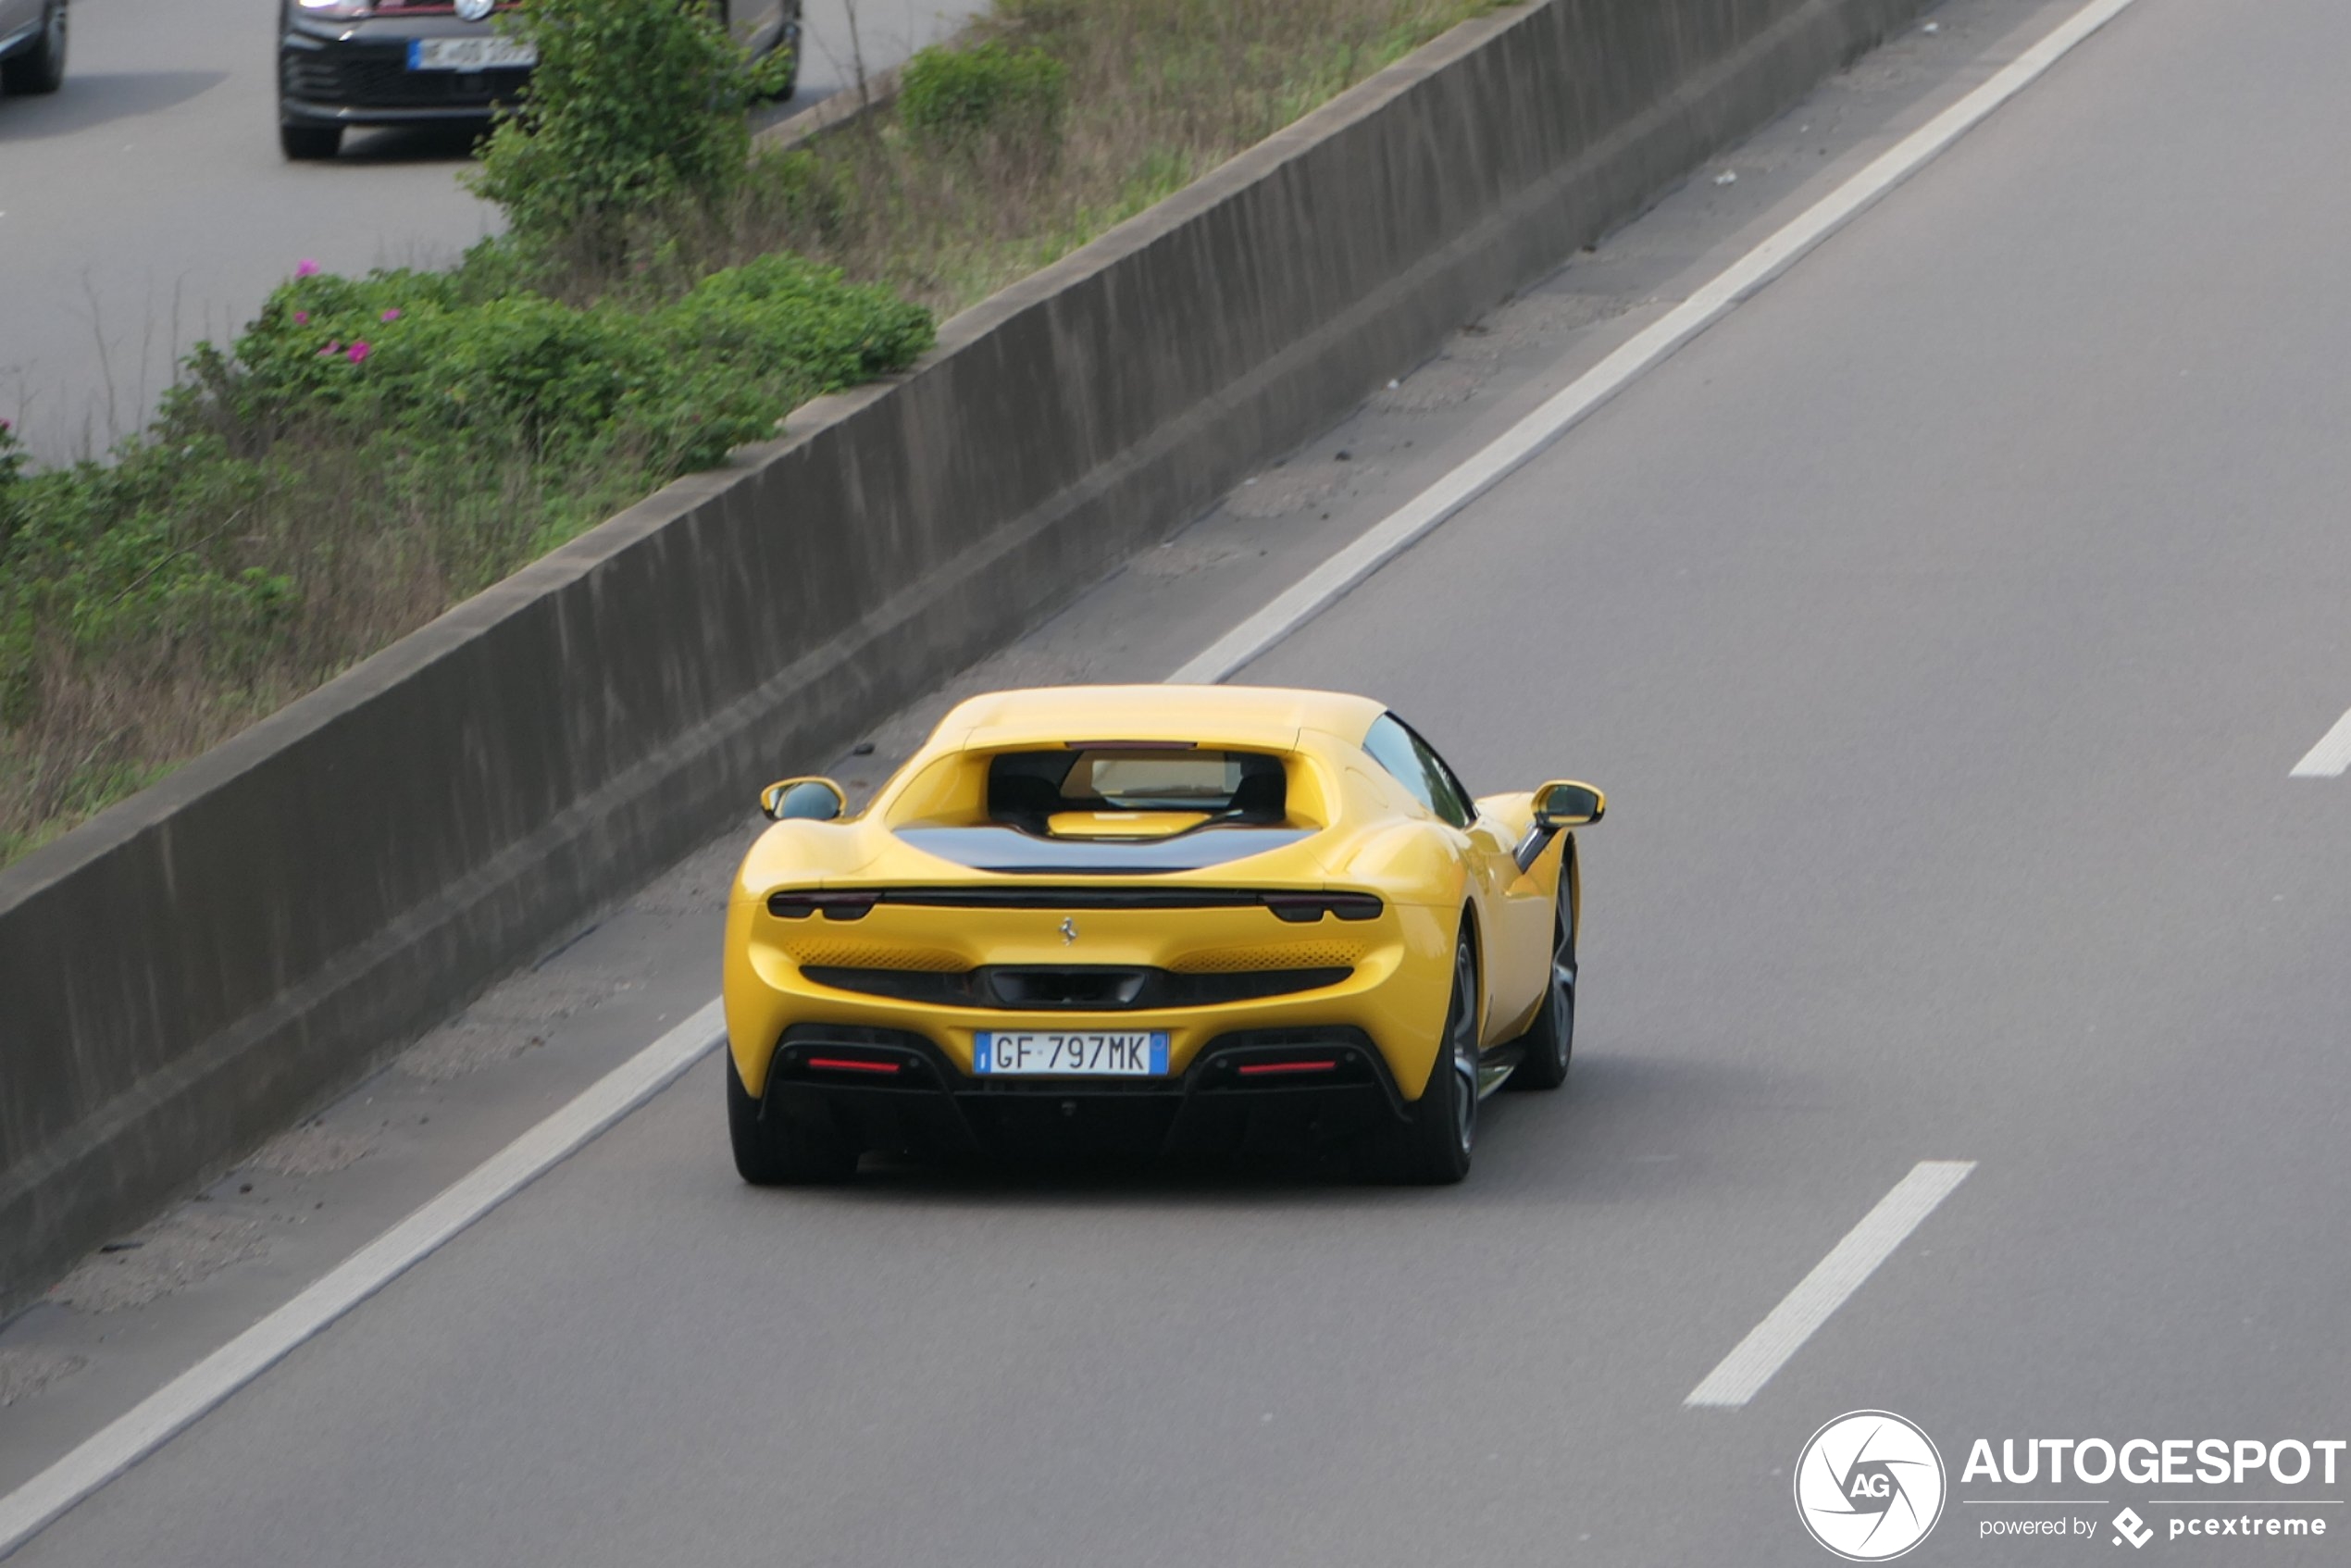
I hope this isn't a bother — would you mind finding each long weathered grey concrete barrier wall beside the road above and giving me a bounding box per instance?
[0,0,1916,1302]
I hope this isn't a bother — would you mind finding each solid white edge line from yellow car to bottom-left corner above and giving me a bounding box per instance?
[0,1002,727,1556]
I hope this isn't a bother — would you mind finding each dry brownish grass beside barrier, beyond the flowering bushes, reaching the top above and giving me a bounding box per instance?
[695,0,1498,315]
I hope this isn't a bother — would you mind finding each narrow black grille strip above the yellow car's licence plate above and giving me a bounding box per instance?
[800,964,1354,1014]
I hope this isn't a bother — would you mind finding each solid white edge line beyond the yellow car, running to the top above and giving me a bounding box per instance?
[1168,0,2137,682]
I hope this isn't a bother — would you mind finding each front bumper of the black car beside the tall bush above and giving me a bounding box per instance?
[278,17,531,125]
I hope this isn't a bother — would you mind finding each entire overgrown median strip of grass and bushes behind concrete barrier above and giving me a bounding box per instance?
[0,0,1495,863]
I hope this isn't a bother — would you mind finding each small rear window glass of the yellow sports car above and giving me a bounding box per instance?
[988,745,1288,823]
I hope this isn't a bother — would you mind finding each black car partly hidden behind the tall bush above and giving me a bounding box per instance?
[277,0,800,157]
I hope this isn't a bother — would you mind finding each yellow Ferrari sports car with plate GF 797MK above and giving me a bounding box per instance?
[724,687,1606,1185]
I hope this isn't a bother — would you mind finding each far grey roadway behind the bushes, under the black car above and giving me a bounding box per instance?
[0,0,978,461]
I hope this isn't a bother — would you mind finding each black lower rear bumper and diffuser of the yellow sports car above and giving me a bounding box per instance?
[762,1025,1408,1154]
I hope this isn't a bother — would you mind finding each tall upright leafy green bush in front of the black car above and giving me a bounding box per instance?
[470,0,790,261]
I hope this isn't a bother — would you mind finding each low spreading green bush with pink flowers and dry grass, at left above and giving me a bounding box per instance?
[0,243,933,863]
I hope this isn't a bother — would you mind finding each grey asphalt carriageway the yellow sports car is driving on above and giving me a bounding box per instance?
[4,0,2351,1568]
